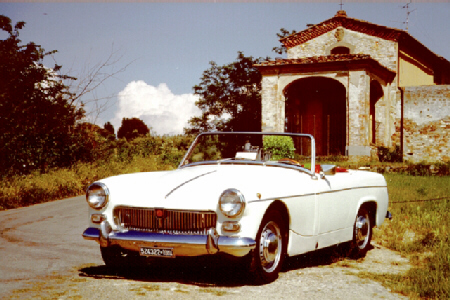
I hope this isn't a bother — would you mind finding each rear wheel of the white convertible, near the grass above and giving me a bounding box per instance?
[351,207,373,258]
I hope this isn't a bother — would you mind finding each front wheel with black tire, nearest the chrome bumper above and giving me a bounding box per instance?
[250,210,288,284]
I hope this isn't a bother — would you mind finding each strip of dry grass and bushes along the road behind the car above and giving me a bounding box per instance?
[0,135,192,210]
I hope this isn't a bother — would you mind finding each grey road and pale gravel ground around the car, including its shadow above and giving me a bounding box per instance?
[0,196,409,300]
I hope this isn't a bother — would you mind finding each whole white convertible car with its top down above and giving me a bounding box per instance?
[83,132,390,282]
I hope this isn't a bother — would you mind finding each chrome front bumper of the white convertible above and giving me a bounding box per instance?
[83,221,256,257]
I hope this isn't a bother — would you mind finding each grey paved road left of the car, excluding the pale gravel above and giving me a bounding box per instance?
[0,196,102,295]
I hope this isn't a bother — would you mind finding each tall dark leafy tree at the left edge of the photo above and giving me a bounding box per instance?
[0,15,85,174]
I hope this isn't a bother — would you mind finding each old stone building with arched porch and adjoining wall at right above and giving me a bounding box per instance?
[256,11,450,162]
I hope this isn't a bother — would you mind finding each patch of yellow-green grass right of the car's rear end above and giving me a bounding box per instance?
[371,174,450,299]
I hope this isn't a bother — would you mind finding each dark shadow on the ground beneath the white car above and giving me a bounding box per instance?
[79,241,373,287]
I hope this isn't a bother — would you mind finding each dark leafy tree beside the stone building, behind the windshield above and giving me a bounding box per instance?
[185,52,267,134]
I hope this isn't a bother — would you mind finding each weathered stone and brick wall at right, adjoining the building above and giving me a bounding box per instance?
[403,85,450,162]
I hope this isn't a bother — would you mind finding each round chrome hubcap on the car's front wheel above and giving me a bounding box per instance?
[259,222,282,273]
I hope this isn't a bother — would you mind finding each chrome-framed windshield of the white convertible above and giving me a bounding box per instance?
[180,132,315,171]
